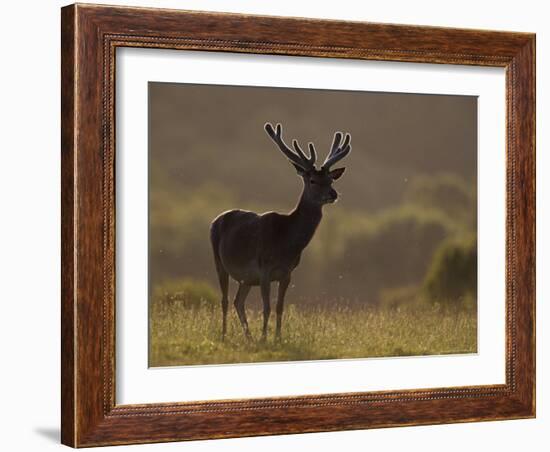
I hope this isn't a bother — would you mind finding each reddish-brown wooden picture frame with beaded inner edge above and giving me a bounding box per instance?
[61,4,535,447]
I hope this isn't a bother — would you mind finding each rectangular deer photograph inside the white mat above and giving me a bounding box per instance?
[148,82,477,367]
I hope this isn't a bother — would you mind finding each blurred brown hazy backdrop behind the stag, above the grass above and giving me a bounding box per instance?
[149,83,477,306]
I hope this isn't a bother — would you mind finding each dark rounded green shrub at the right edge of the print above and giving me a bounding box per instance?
[423,237,477,303]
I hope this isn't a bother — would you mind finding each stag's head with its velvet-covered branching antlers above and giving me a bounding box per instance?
[265,123,351,204]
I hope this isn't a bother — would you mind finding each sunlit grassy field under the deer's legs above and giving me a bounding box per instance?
[149,301,477,367]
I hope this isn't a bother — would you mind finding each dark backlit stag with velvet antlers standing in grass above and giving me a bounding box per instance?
[210,123,351,340]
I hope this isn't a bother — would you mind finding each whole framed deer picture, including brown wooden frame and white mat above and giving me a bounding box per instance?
[60,4,536,447]
